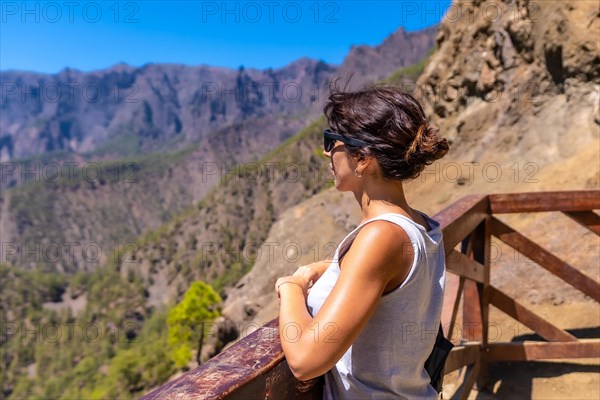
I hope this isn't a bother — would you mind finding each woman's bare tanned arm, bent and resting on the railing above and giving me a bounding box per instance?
[276,221,410,380]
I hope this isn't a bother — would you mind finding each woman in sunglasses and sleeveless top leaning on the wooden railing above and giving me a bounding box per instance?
[276,86,448,399]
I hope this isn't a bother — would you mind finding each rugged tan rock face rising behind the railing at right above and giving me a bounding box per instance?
[408,1,600,307]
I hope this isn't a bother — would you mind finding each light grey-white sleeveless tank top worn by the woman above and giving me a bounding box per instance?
[307,213,446,400]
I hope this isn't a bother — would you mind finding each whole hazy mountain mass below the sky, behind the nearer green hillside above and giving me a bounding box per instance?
[0,28,434,273]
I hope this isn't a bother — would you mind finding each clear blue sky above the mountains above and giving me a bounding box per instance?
[0,0,450,73]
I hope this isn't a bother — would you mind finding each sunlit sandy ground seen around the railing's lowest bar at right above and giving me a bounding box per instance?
[444,300,600,400]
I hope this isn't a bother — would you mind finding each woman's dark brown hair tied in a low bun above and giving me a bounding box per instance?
[323,85,449,180]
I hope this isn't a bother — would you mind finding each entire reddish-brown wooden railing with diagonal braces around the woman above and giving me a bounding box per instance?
[143,190,600,400]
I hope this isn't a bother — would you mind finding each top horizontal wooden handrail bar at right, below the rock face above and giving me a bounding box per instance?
[489,190,600,214]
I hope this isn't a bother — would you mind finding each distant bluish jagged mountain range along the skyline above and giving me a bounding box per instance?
[0,27,436,161]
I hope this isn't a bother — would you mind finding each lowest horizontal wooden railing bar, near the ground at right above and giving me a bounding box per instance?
[484,339,600,362]
